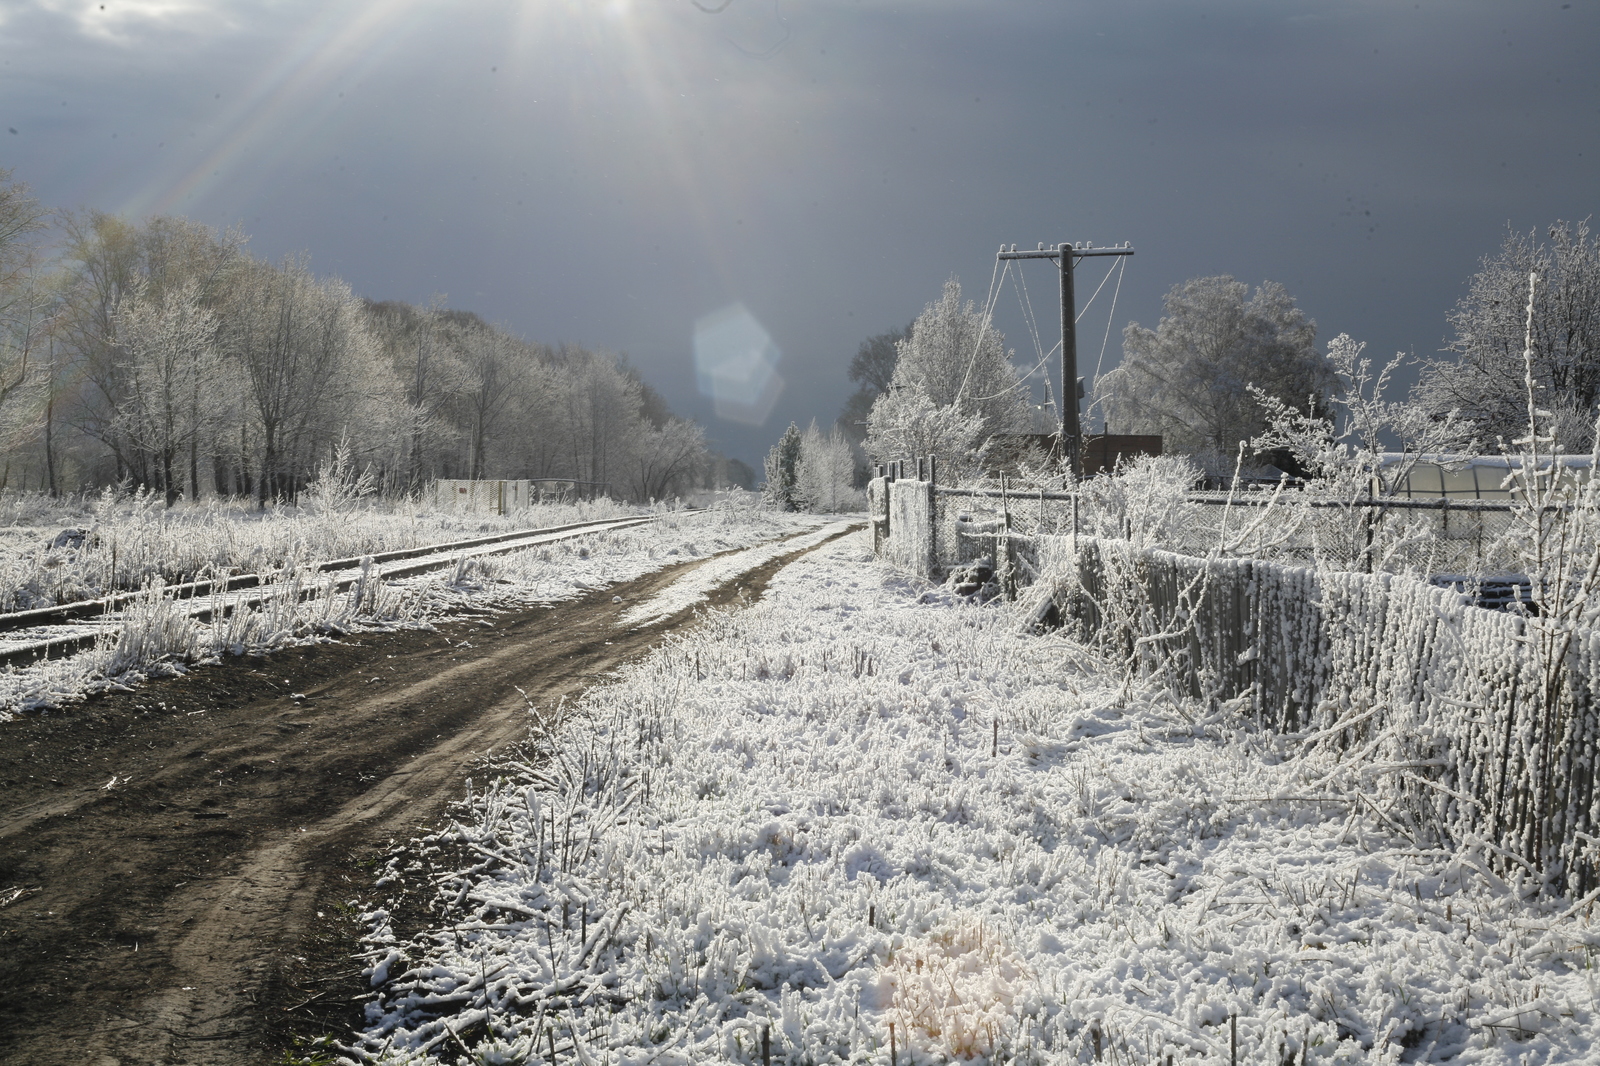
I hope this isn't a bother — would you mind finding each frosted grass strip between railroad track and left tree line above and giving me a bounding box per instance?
[0,490,645,611]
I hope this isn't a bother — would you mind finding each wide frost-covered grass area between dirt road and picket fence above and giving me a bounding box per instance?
[349,536,1600,1066]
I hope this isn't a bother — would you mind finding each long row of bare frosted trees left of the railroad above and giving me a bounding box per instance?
[0,171,750,503]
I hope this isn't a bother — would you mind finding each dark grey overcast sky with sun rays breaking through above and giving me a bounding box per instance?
[0,0,1600,464]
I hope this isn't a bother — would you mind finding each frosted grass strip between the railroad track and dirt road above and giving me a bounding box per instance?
[0,504,822,722]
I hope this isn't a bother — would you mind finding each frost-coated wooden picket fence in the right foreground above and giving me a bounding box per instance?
[1056,538,1600,895]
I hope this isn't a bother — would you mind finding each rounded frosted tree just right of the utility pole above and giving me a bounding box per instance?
[1093,275,1336,471]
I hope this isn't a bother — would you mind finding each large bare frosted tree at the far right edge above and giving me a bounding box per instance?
[1421,221,1600,451]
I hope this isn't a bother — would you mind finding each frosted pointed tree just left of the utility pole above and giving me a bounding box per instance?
[867,279,1029,477]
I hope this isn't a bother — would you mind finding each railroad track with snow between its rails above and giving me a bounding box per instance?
[0,511,693,667]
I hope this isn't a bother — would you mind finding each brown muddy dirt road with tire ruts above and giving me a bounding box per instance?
[0,521,864,1066]
